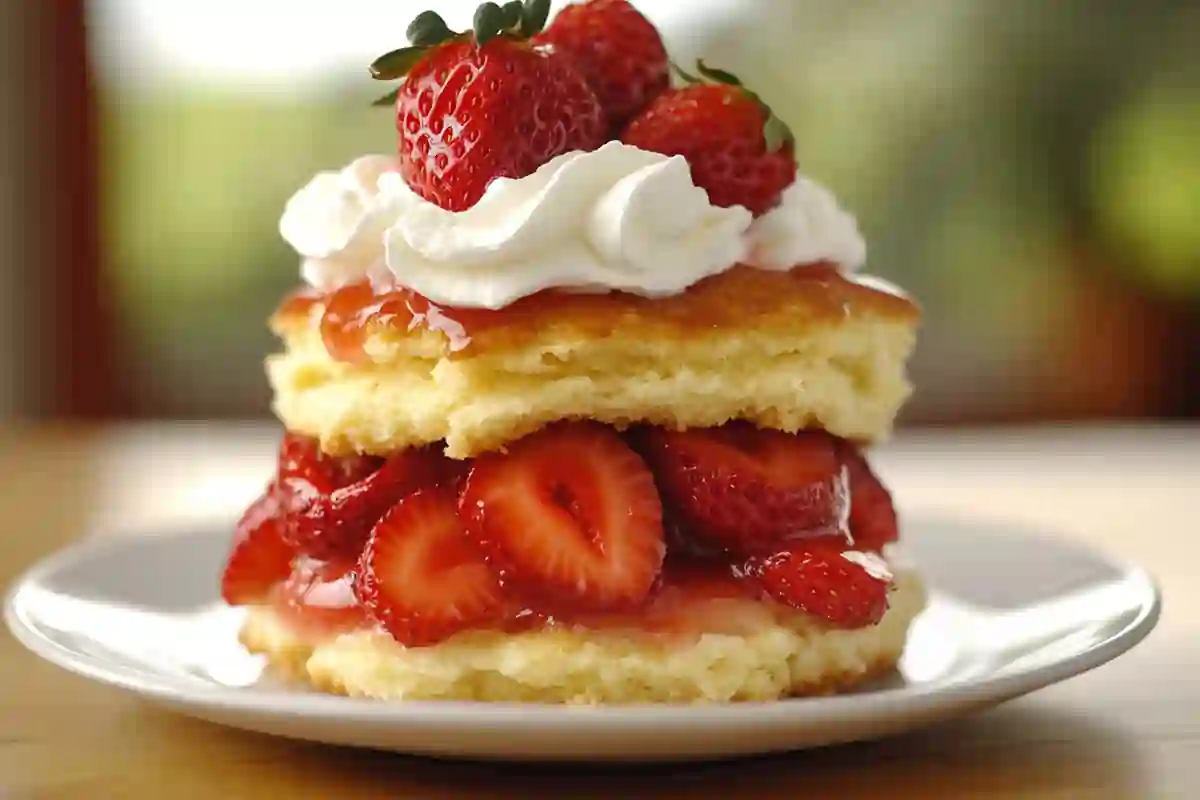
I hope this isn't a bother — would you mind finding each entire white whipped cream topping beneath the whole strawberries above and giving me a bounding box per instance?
[280,142,866,308]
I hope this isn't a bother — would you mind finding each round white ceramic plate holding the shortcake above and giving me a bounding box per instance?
[5,518,1159,760]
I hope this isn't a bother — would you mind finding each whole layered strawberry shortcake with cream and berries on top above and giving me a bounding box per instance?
[222,0,924,703]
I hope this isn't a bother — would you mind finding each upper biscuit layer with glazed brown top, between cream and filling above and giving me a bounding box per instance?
[269,266,919,458]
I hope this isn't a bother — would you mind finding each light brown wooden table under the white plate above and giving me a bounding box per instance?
[0,425,1200,800]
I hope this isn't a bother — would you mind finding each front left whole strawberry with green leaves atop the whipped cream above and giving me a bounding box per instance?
[371,0,606,211]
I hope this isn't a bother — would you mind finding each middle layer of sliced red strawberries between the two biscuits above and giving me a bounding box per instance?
[222,422,898,646]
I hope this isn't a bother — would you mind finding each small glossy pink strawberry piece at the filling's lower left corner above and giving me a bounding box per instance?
[275,554,371,636]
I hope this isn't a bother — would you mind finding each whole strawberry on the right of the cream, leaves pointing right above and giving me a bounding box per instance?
[620,61,796,216]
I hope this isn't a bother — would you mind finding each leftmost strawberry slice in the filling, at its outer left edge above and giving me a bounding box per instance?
[221,487,295,606]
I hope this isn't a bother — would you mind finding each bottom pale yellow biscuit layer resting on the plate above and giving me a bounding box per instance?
[241,572,925,704]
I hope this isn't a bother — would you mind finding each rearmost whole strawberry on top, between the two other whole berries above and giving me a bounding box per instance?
[535,0,671,132]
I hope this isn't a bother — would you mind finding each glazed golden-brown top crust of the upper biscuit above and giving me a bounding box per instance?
[270,264,920,363]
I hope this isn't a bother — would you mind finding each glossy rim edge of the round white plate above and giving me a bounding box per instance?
[4,513,1163,732]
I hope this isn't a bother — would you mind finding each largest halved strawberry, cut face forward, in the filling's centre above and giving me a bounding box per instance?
[461,422,666,610]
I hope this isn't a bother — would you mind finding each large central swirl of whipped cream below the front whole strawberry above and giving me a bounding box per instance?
[386,142,751,308]
